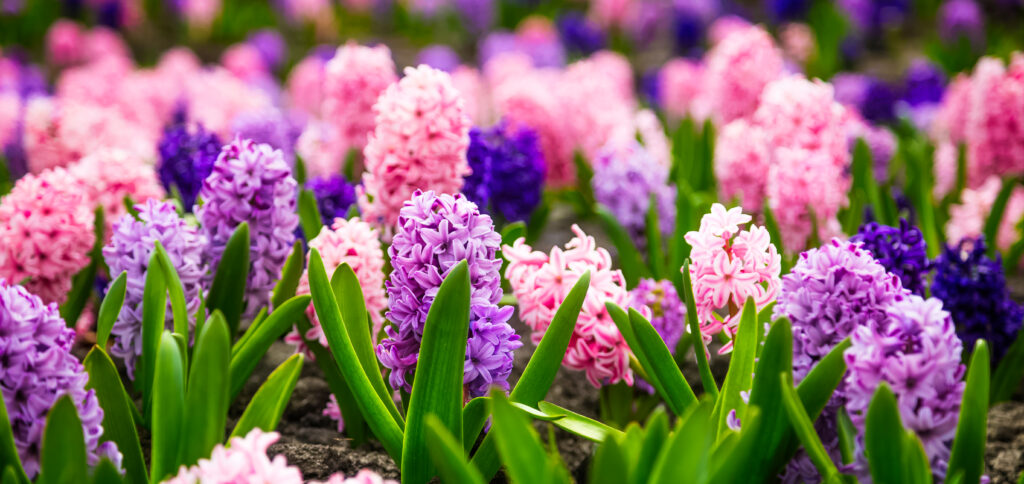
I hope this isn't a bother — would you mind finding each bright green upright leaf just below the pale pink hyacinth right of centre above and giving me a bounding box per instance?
[712,298,758,441]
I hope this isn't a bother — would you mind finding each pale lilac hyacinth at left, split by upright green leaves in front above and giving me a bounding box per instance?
[103,199,207,379]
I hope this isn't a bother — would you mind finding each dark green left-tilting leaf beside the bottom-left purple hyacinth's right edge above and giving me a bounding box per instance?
[83,347,148,484]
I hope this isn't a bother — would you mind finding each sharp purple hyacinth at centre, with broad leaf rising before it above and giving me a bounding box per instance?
[377,190,522,397]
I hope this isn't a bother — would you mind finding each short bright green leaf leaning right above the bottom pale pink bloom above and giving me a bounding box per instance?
[231,353,303,437]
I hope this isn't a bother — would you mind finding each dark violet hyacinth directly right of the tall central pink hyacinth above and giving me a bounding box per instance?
[462,123,545,221]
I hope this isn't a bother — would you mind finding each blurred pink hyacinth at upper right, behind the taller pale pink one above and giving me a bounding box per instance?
[703,26,782,123]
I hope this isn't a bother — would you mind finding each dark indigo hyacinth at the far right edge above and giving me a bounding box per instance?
[932,238,1024,362]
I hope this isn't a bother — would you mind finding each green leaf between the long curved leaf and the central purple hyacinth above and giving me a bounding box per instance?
[331,263,401,427]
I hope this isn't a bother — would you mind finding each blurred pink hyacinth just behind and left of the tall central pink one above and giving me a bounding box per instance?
[323,42,397,152]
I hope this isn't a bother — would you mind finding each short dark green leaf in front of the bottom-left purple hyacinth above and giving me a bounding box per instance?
[38,395,88,484]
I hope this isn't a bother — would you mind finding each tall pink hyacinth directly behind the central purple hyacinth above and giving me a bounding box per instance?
[359,65,470,227]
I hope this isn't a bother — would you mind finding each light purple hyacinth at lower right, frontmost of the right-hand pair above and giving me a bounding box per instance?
[845,295,965,476]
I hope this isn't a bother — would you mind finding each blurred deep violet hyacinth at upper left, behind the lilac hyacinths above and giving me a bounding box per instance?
[157,120,221,211]
